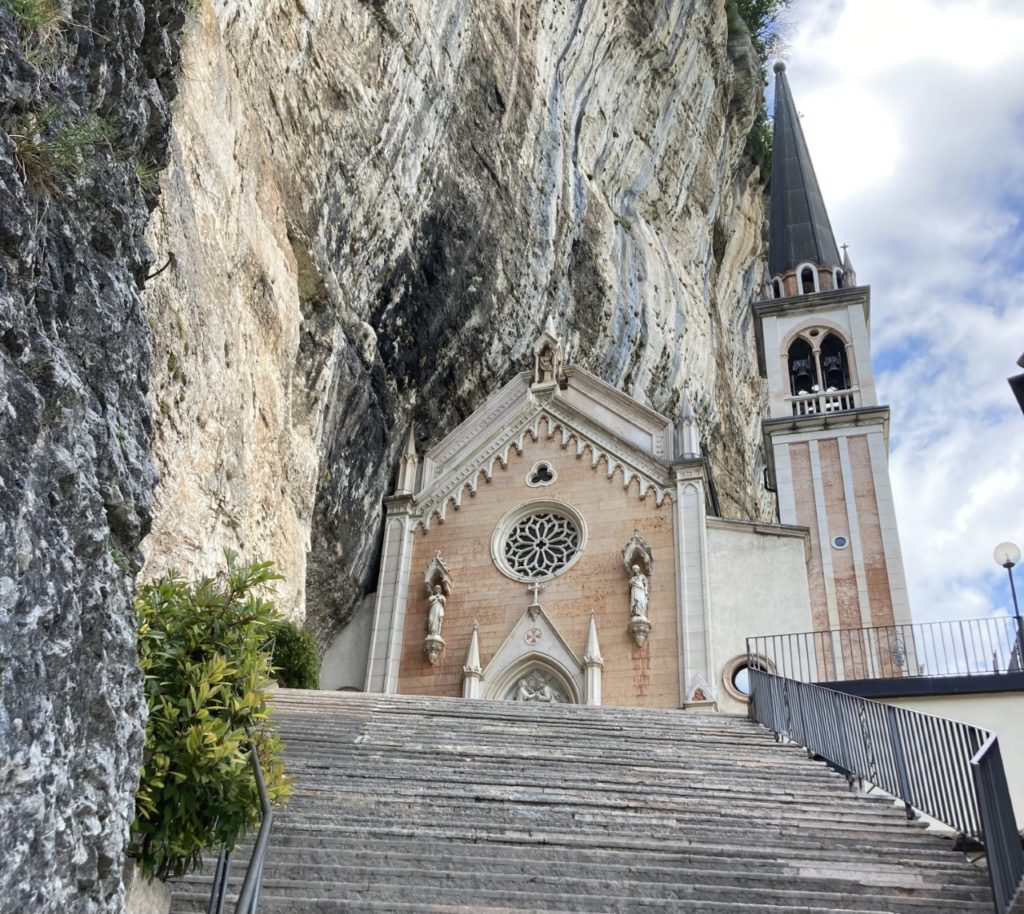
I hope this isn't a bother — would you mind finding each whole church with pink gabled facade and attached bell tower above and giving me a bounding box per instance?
[333,64,910,711]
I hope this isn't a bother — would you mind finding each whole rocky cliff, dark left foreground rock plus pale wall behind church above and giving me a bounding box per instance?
[0,0,769,912]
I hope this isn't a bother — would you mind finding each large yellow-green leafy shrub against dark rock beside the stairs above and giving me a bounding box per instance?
[129,553,288,879]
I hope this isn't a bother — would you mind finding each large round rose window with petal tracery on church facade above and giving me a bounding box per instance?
[492,502,585,580]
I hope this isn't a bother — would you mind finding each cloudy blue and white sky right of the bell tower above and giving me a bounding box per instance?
[782,0,1024,621]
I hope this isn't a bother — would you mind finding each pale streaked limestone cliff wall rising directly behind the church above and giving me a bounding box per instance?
[145,0,771,638]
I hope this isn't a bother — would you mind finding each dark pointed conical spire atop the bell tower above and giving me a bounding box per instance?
[768,60,842,276]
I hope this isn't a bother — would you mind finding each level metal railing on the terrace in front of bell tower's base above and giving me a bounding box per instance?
[746,616,1024,683]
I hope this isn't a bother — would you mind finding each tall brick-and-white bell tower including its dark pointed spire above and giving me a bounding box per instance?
[754,61,910,628]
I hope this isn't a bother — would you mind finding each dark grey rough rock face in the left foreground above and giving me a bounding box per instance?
[0,0,184,914]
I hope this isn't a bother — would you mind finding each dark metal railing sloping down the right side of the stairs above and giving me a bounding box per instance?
[750,658,1024,914]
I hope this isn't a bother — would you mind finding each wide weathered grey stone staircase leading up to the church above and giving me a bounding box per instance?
[165,691,992,914]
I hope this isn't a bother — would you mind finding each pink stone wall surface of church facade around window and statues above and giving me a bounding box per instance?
[398,425,679,707]
